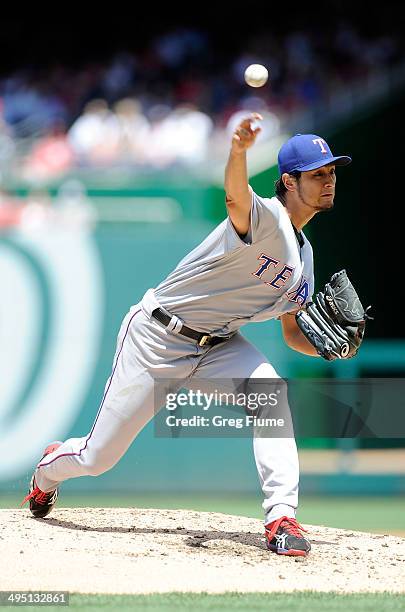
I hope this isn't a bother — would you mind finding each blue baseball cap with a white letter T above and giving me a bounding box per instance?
[278,134,352,176]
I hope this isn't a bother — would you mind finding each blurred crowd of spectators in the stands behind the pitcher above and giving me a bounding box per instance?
[0,22,405,181]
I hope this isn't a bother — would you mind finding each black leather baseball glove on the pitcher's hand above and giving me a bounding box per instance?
[295,270,372,361]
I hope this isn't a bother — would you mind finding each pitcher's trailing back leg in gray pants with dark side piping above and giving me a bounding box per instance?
[35,309,186,493]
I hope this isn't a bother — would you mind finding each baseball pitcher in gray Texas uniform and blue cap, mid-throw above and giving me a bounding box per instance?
[24,113,366,556]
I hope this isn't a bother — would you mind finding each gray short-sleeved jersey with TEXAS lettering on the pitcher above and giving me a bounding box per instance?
[155,192,314,335]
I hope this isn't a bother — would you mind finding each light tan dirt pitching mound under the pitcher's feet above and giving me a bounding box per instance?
[0,508,405,593]
